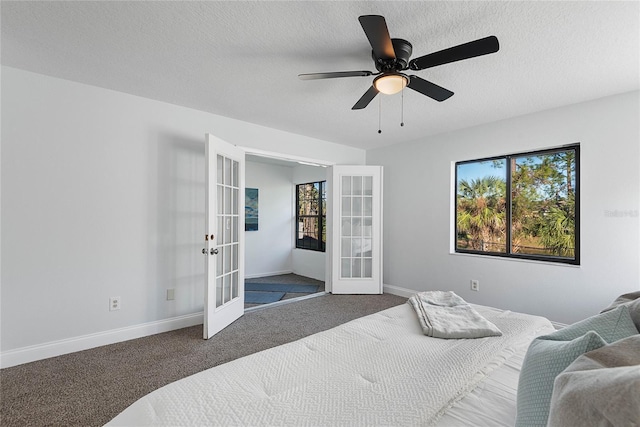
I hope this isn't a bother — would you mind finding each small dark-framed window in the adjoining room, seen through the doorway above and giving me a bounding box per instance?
[296,181,327,252]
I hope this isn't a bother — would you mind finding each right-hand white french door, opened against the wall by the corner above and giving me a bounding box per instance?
[327,166,383,294]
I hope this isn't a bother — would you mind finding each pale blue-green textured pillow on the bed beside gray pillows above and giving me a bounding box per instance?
[516,306,638,427]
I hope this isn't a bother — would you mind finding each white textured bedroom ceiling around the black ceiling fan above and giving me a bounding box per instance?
[1,1,640,148]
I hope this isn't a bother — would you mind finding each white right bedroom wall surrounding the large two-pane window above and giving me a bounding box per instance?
[367,92,640,323]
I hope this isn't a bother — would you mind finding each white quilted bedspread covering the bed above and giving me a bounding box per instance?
[109,304,551,426]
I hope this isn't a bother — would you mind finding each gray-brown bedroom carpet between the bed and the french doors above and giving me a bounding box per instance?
[0,295,406,426]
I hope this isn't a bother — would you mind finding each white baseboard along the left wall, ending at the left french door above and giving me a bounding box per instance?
[0,312,204,368]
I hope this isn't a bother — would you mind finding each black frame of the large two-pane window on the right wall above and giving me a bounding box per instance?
[453,143,580,265]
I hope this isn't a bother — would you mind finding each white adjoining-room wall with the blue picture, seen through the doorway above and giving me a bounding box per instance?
[245,162,295,278]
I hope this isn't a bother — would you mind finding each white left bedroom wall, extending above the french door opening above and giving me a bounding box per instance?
[0,67,365,363]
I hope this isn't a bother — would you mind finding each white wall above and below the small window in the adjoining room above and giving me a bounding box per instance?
[292,165,327,281]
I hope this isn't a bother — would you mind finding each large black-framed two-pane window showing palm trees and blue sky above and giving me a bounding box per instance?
[455,145,580,264]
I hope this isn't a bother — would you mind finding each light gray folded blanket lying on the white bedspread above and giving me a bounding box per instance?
[408,291,502,339]
